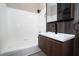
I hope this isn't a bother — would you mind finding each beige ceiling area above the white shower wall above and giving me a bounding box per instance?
[6,3,46,13]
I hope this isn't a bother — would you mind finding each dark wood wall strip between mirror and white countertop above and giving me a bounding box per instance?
[47,21,74,34]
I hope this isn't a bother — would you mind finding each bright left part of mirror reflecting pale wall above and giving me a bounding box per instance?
[47,3,57,22]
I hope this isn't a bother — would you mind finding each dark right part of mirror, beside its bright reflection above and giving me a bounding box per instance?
[57,3,74,20]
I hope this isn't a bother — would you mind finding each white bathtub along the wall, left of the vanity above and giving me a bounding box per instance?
[0,40,40,56]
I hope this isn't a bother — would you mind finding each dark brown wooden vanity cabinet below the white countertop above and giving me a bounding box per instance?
[38,35,73,56]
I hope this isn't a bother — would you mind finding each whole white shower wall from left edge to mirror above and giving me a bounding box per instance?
[0,7,46,52]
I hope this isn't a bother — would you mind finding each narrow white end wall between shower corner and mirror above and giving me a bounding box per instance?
[38,8,46,32]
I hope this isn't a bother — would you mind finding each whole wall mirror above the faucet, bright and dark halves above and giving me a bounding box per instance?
[47,3,74,23]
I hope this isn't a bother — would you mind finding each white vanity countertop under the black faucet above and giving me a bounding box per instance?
[39,32,75,42]
